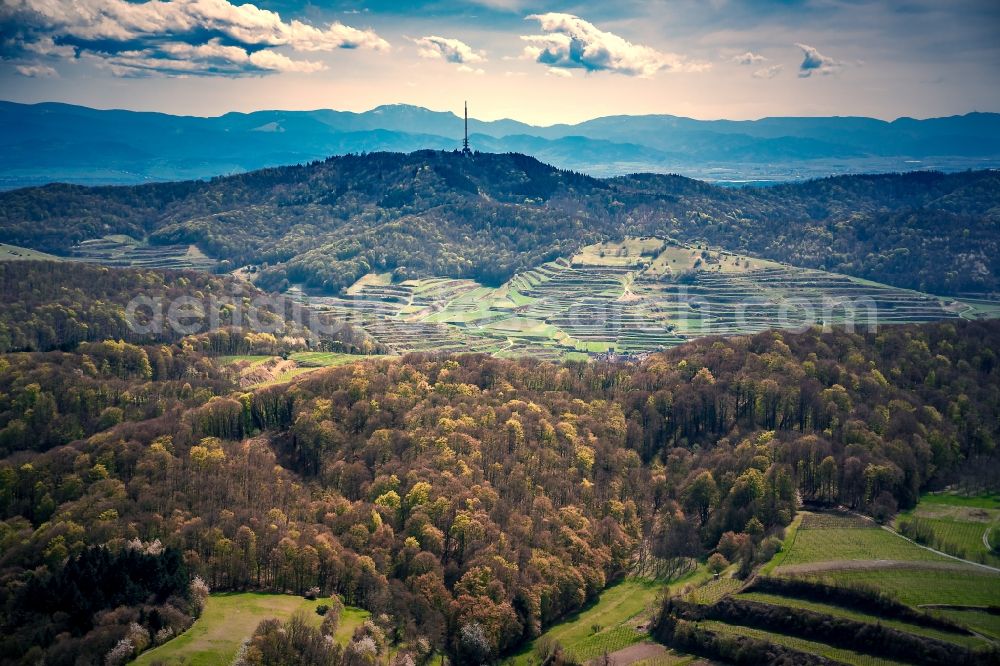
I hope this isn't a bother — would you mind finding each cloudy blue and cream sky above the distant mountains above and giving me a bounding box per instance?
[0,0,1000,125]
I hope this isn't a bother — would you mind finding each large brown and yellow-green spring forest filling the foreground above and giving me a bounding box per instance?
[0,274,1000,664]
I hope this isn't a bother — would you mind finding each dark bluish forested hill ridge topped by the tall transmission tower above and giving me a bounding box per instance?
[0,151,1000,294]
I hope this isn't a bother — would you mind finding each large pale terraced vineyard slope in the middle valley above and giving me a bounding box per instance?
[291,238,995,359]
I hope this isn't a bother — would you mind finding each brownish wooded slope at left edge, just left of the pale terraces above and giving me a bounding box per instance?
[0,261,376,354]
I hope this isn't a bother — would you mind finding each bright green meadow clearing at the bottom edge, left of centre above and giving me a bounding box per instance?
[136,592,368,666]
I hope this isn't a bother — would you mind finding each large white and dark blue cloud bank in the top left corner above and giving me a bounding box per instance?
[0,0,389,76]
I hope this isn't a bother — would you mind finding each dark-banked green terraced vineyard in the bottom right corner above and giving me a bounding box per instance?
[660,512,1000,666]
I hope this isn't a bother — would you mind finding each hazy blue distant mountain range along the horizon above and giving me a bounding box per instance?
[0,102,1000,189]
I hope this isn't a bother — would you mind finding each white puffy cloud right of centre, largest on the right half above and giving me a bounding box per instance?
[521,13,709,78]
